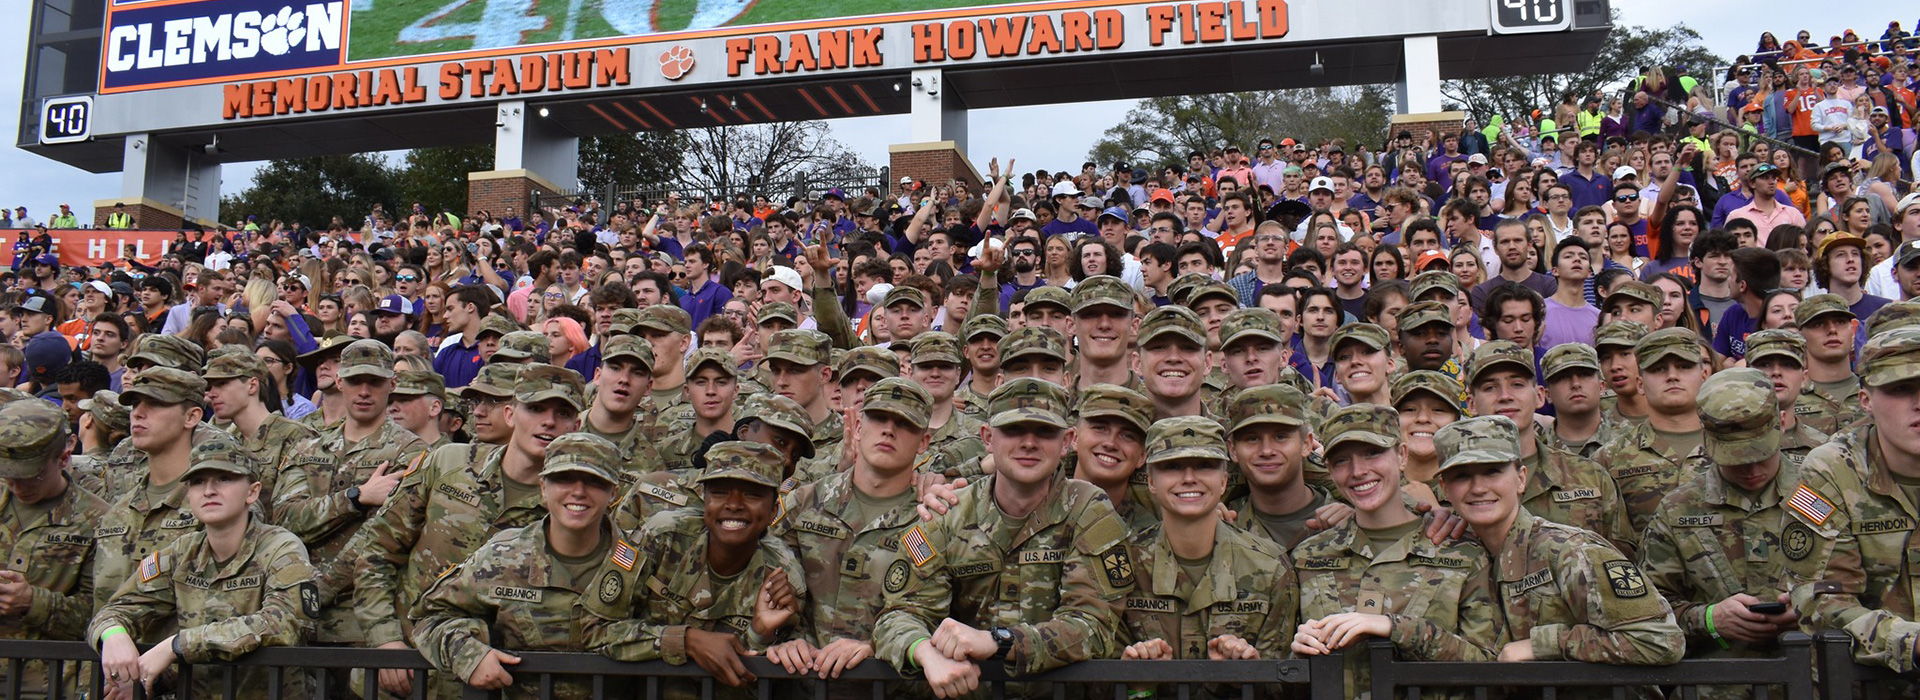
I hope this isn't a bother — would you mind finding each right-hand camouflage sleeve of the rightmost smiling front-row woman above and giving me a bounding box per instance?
[1528,541,1686,665]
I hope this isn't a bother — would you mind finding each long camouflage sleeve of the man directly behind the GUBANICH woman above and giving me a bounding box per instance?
[355,455,437,644]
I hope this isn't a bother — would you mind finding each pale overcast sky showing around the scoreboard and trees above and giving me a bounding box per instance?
[0,0,1889,222]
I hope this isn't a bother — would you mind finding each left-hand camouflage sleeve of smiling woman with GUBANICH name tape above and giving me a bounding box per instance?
[413,545,497,681]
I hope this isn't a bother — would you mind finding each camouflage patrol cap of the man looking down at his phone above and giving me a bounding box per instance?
[1699,366,1780,466]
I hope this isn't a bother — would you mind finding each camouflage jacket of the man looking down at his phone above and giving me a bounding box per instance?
[1640,458,1822,658]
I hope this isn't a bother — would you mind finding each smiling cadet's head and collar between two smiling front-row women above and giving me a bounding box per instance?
[1227,384,1350,550]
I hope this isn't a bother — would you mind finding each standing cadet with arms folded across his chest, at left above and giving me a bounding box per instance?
[273,339,426,644]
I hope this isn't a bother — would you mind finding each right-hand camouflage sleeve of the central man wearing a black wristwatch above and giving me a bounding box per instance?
[1006,495,1133,675]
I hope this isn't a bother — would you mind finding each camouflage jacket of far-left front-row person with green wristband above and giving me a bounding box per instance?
[86,522,321,698]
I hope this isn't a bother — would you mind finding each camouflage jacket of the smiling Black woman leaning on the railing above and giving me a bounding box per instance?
[580,508,806,665]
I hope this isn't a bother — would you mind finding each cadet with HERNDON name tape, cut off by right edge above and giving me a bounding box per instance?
[1782,328,1920,675]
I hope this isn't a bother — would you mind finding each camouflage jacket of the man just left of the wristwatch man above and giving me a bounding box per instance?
[783,472,920,646]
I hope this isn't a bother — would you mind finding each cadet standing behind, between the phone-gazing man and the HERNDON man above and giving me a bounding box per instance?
[1793,293,1866,435]
